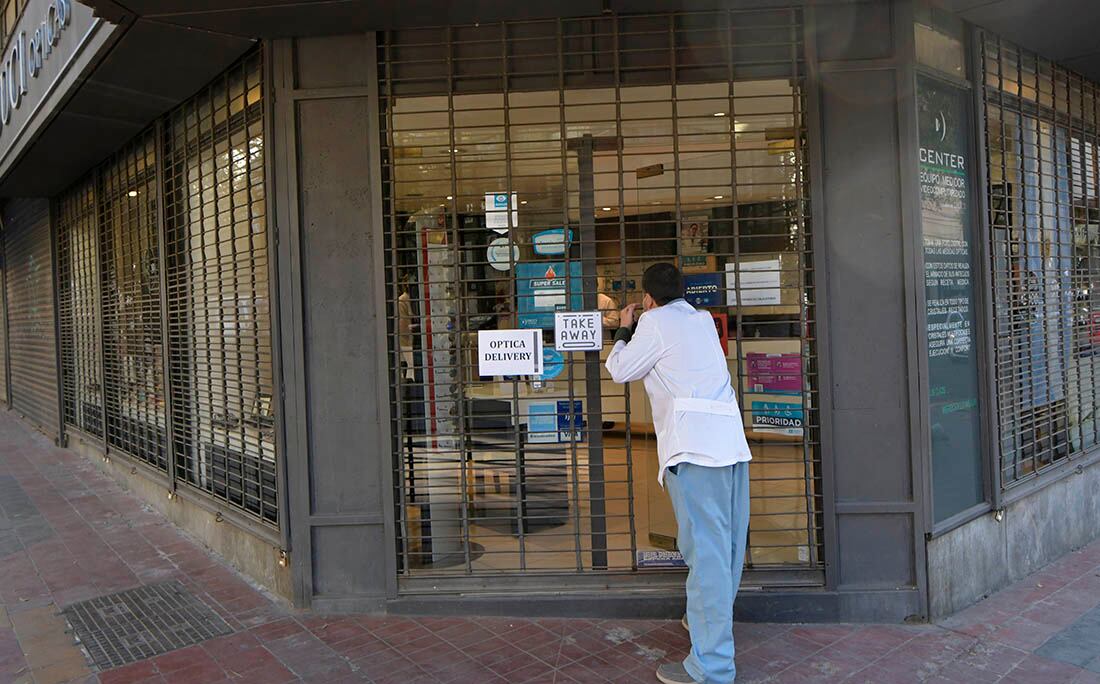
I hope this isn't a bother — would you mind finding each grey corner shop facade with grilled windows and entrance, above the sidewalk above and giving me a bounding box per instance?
[0,0,1100,621]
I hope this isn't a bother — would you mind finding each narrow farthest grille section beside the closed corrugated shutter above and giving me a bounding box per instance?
[55,179,103,437]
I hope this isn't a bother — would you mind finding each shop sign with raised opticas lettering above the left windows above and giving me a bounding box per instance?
[0,0,73,134]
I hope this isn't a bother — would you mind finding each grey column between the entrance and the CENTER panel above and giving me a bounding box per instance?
[806,1,927,620]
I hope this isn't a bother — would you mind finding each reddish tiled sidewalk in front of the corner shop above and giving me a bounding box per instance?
[0,412,1100,684]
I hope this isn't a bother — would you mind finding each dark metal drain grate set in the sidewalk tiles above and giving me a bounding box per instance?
[62,580,233,670]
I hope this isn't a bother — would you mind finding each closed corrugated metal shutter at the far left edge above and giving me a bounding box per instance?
[4,199,58,438]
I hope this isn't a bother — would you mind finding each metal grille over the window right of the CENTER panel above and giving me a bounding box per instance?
[981,35,1100,485]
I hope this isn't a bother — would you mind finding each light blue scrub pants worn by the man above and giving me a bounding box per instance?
[664,463,749,684]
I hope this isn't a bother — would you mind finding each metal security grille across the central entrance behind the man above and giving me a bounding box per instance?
[378,9,822,582]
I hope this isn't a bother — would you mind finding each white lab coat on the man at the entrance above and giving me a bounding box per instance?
[607,299,752,485]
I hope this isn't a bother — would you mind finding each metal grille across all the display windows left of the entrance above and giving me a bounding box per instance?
[47,51,279,530]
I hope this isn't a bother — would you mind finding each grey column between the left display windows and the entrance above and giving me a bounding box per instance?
[270,34,397,611]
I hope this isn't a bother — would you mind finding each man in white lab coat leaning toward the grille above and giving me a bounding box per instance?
[607,264,752,684]
